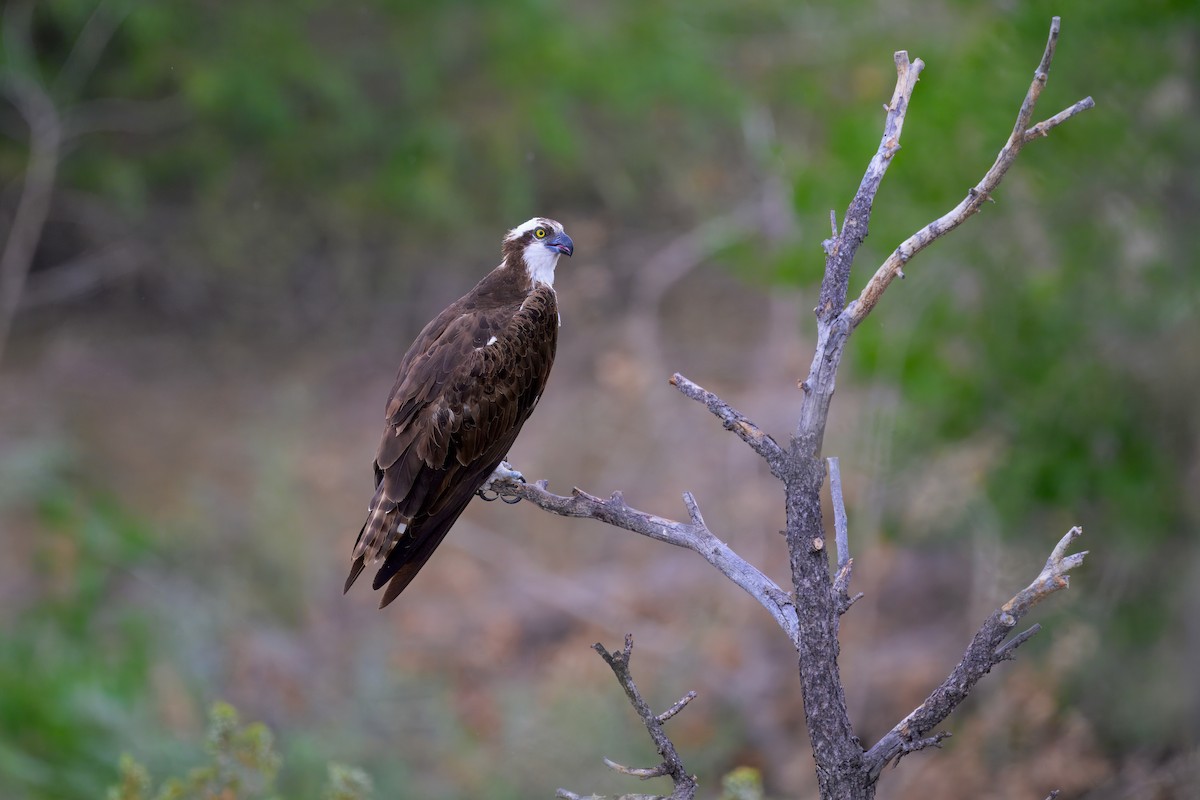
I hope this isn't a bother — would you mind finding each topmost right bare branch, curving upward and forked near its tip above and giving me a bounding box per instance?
[845,17,1096,327]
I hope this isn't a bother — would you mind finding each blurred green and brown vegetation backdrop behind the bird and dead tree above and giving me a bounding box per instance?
[0,0,1200,800]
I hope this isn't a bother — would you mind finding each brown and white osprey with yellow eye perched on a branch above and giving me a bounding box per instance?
[346,217,575,608]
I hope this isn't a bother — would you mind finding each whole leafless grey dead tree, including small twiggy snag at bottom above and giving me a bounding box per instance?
[493,17,1093,800]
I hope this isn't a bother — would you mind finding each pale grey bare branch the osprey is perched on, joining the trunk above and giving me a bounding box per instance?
[491,477,799,644]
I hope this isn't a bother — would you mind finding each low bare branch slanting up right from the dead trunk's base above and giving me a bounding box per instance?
[863,528,1086,780]
